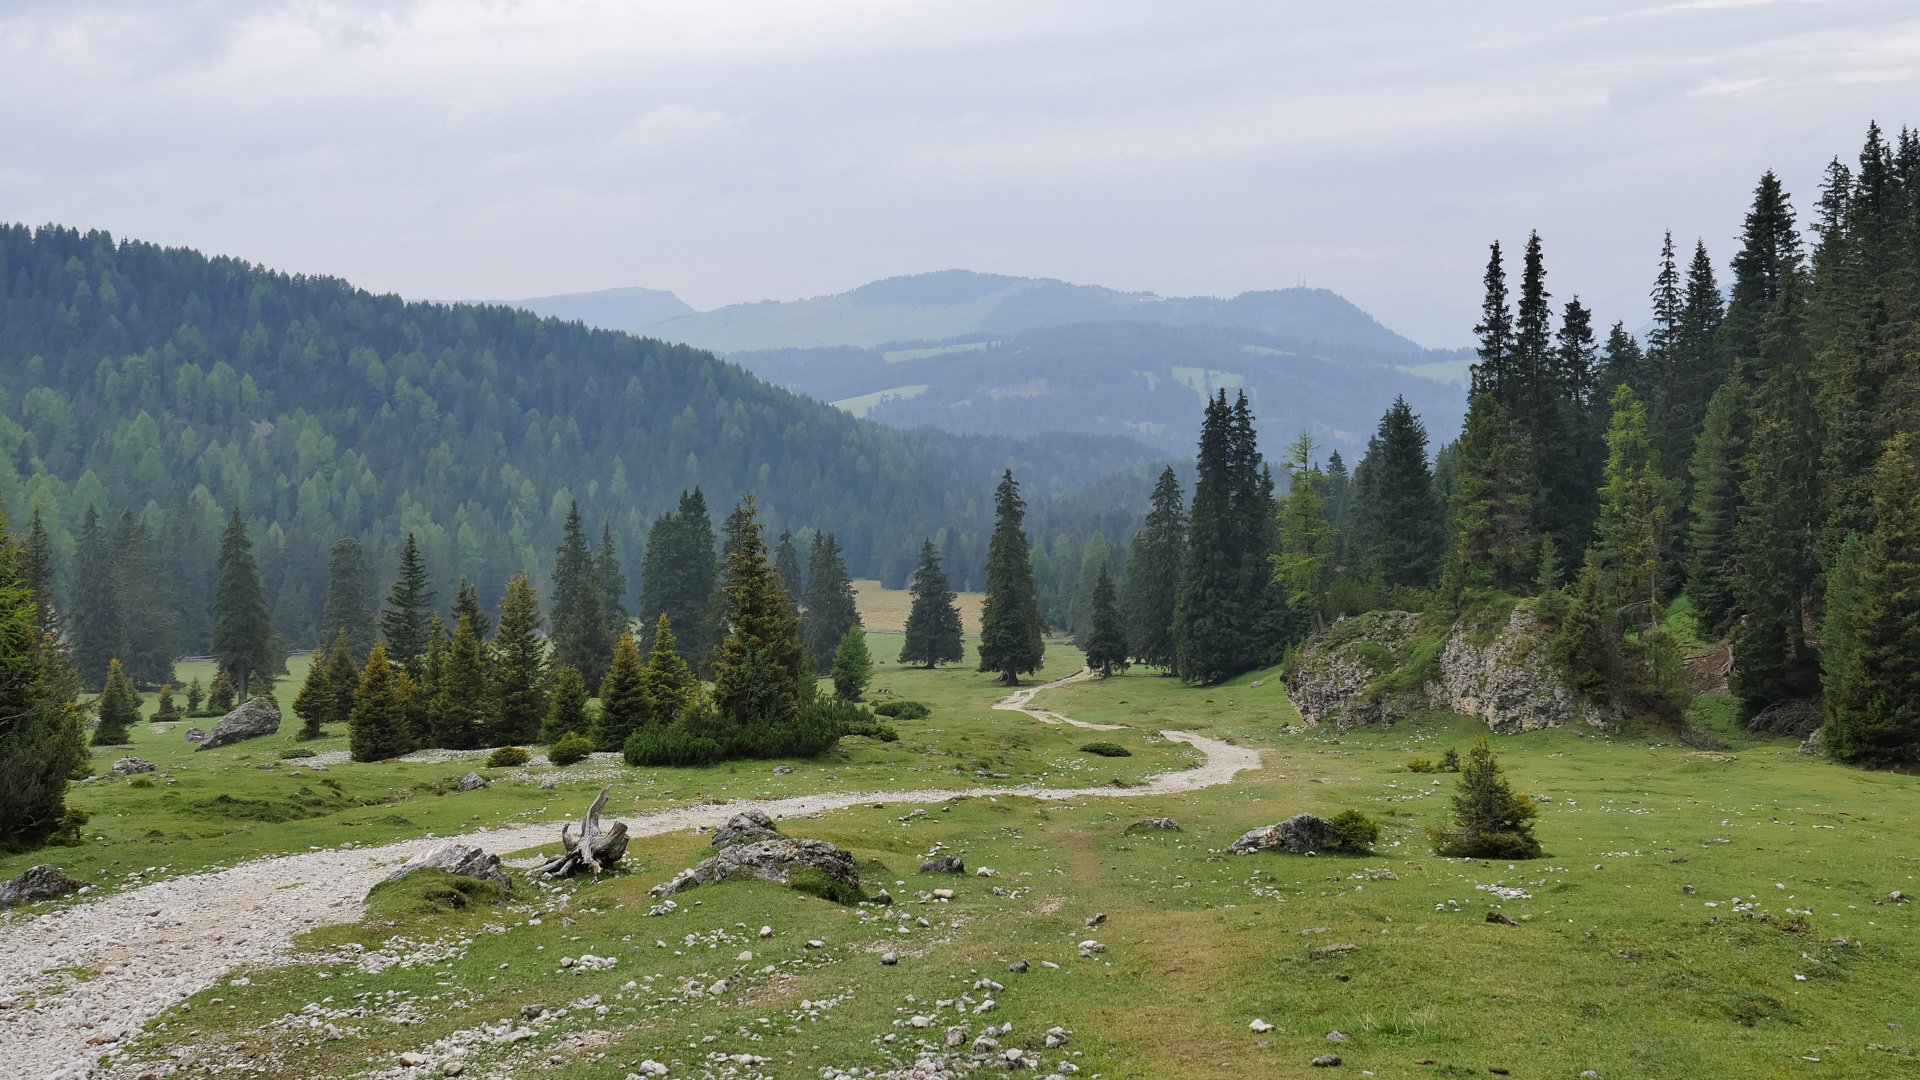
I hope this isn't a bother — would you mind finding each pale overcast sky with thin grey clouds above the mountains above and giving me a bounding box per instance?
[0,0,1920,348]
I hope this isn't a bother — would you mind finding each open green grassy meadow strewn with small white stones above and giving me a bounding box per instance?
[15,642,1920,1080]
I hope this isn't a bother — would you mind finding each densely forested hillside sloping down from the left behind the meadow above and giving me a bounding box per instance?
[0,225,1152,653]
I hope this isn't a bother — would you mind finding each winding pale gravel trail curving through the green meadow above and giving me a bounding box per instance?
[0,671,1260,1080]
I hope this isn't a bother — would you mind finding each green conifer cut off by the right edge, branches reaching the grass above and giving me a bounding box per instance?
[1824,434,1920,767]
